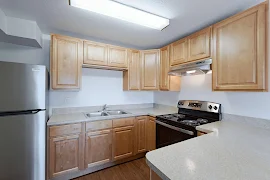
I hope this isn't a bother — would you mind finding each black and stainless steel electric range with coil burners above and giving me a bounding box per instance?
[156,101,222,148]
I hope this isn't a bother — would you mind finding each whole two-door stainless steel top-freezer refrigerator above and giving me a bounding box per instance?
[0,62,48,180]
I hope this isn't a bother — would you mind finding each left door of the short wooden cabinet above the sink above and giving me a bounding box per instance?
[83,41,108,66]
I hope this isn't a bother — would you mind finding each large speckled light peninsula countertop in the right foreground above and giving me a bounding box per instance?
[146,120,270,180]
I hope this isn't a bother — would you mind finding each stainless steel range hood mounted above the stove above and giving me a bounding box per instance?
[168,59,212,76]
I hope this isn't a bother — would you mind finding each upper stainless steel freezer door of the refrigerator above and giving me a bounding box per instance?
[0,62,48,113]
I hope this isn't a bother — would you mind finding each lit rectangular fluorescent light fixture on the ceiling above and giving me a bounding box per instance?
[69,0,170,30]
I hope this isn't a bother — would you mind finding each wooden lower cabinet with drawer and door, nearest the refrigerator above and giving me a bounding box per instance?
[49,124,84,178]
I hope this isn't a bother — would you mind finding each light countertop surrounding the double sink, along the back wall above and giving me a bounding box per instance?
[47,107,177,126]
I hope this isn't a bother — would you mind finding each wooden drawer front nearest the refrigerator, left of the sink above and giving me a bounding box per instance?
[50,124,82,137]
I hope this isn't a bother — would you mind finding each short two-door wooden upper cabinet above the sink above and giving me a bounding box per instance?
[83,41,128,70]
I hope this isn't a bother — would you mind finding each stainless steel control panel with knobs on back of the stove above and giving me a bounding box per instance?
[177,100,221,113]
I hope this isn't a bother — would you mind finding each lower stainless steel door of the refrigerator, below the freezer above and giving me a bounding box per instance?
[0,111,46,180]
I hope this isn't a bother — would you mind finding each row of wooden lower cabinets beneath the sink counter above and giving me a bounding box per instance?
[48,116,156,179]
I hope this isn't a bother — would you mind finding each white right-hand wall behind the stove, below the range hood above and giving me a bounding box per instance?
[154,74,270,119]
